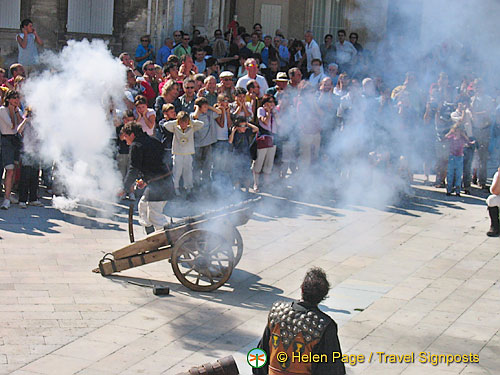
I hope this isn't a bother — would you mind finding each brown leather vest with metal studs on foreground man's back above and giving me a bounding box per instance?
[268,302,330,375]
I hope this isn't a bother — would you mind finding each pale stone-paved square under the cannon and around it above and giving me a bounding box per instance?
[0,180,500,375]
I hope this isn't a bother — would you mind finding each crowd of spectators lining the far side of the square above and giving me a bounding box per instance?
[0,23,500,213]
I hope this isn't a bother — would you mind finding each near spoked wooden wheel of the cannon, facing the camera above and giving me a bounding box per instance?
[171,229,234,292]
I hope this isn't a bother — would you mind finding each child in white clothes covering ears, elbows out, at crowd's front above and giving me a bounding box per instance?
[163,111,204,196]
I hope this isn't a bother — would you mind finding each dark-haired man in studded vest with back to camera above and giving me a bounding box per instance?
[253,267,345,375]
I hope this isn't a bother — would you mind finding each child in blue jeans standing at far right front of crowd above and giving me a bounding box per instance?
[445,123,474,197]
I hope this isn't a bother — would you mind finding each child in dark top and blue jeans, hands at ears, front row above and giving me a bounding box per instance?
[229,116,259,190]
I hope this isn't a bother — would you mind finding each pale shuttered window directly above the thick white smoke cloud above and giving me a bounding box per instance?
[67,0,114,35]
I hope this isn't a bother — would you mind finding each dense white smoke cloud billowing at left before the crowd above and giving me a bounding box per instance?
[23,40,125,212]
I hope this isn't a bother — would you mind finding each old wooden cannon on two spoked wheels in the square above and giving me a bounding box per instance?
[93,199,258,291]
